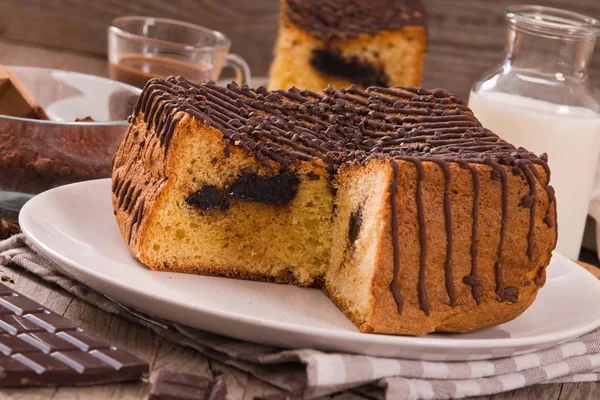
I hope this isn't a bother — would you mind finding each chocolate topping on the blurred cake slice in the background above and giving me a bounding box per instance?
[283,0,427,40]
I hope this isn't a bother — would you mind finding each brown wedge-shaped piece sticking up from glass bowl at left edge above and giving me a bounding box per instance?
[0,65,50,120]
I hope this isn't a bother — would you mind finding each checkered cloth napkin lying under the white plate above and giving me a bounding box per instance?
[0,234,600,399]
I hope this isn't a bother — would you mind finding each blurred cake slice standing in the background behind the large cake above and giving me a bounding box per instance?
[269,0,426,90]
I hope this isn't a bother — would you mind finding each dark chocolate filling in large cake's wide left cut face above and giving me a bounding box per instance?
[186,171,299,211]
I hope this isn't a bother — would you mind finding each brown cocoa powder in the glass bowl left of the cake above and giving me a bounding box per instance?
[0,117,127,194]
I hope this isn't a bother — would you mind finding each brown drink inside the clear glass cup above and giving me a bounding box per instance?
[109,55,211,88]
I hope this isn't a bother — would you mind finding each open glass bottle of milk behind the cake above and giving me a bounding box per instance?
[469,5,600,259]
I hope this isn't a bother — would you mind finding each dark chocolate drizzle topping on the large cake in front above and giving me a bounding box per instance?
[129,77,556,314]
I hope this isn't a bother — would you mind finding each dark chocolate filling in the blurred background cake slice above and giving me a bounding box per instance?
[310,49,390,87]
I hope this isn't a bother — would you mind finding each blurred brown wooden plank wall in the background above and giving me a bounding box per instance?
[0,0,600,98]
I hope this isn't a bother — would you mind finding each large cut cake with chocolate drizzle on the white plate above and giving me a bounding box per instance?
[113,77,556,334]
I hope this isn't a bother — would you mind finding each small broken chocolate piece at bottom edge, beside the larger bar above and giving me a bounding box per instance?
[148,371,227,400]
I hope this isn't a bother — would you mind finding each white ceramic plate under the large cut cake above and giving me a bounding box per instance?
[20,179,600,360]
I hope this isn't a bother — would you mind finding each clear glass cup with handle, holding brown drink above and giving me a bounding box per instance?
[108,16,250,88]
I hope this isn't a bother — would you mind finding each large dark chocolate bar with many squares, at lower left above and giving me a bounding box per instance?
[0,284,149,387]
